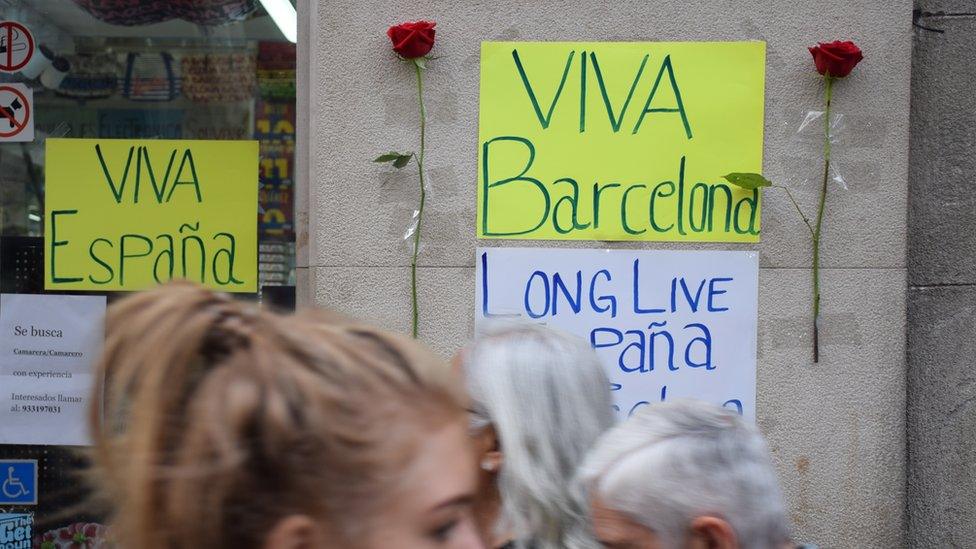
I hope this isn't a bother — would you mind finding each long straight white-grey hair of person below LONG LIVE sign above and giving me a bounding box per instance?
[463,322,614,549]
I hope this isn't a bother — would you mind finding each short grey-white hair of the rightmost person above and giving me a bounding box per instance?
[580,400,789,549]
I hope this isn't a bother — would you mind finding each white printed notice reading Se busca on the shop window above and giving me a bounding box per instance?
[0,294,105,445]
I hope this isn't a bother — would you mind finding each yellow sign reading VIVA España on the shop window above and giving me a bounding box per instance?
[44,139,258,292]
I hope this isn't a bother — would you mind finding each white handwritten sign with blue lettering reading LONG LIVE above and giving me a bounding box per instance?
[475,248,759,418]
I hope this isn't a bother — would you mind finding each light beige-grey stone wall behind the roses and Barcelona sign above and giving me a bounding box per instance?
[299,0,912,548]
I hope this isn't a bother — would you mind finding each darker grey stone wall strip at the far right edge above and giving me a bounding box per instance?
[908,0,976,548]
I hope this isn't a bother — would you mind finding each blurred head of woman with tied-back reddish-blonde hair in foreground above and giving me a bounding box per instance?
[91,283,483,549]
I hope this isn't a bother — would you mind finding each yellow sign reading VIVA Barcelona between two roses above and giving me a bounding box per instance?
[477,42,766,242]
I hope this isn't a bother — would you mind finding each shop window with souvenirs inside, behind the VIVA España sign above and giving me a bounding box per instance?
[0,0,296,536]
